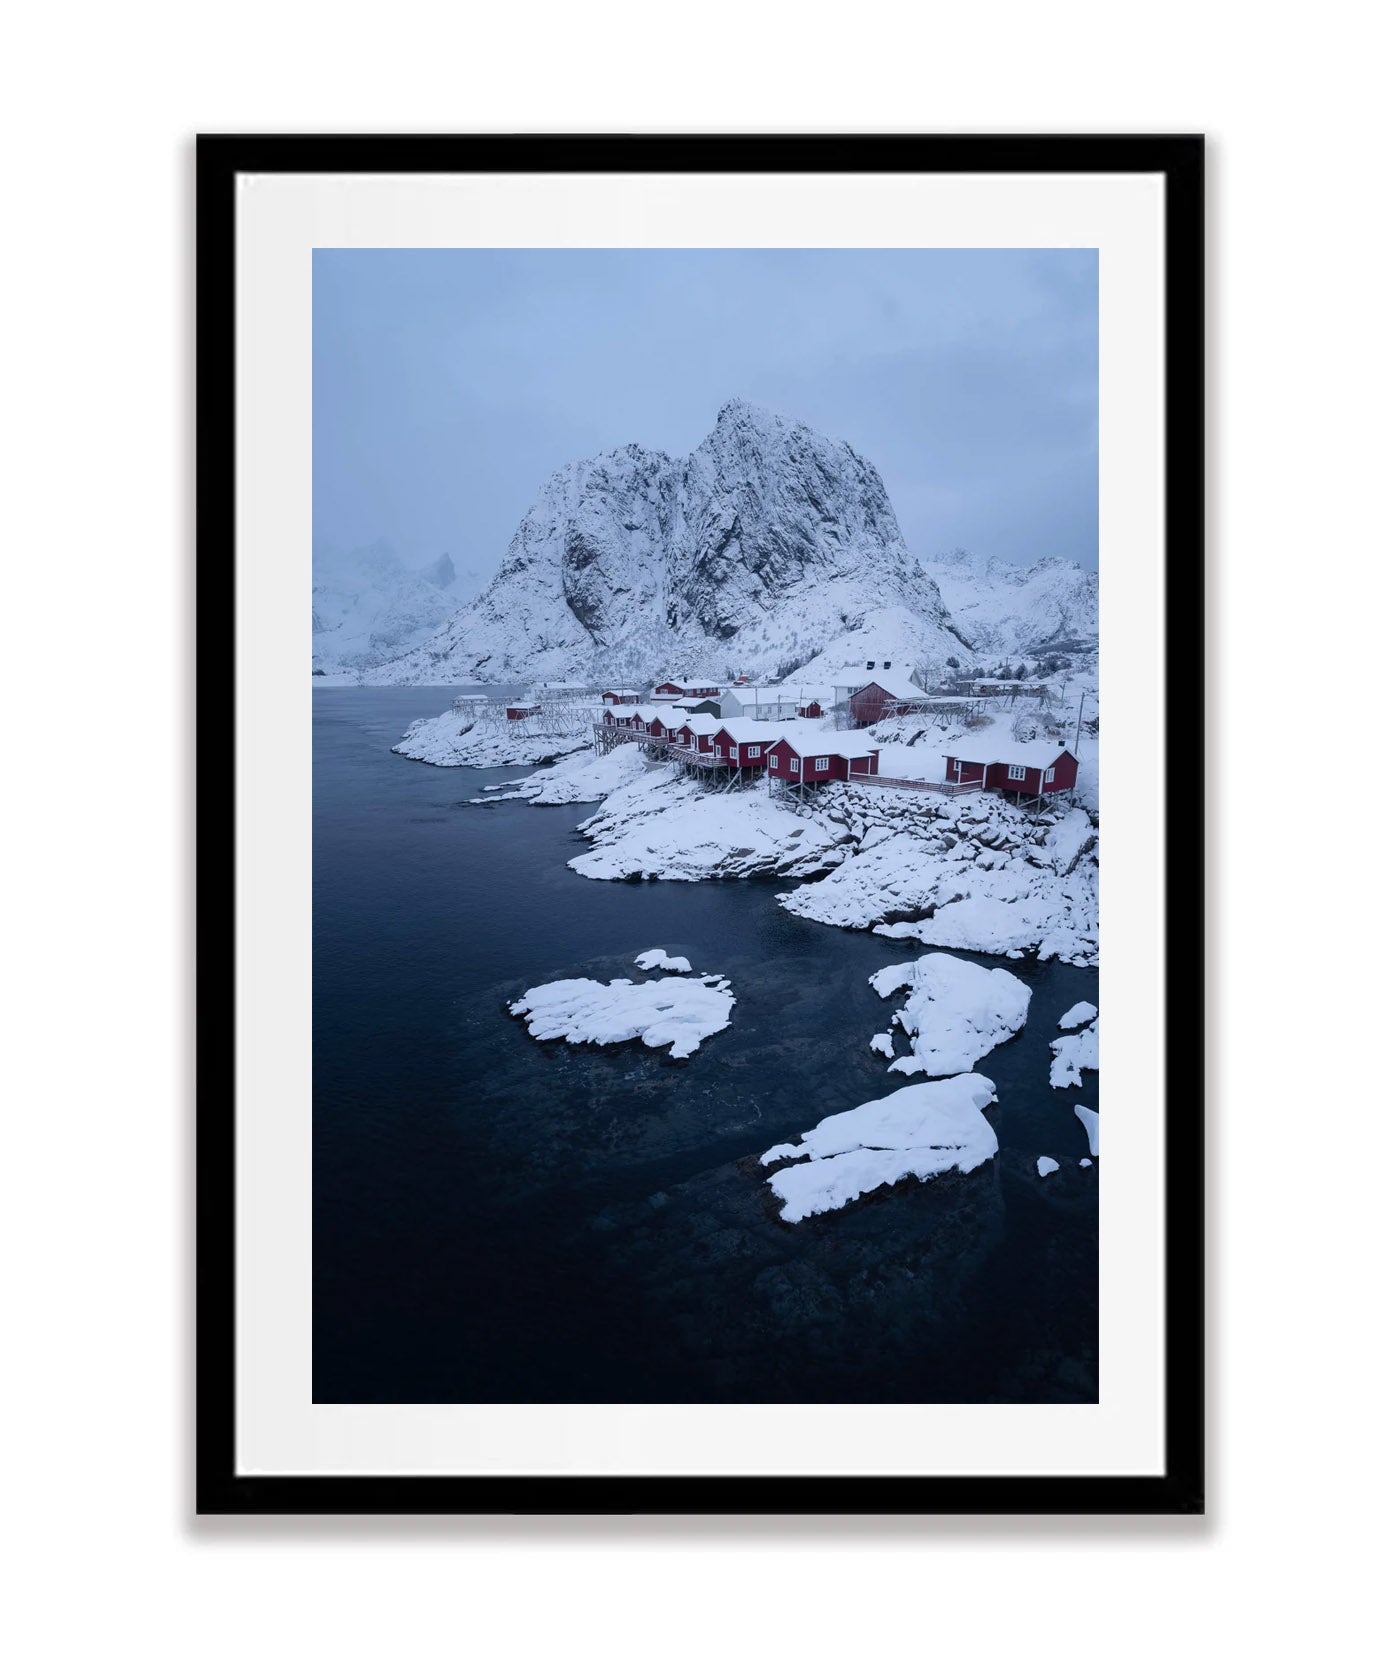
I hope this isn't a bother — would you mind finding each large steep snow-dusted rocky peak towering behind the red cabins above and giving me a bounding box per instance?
[373,402,966,682]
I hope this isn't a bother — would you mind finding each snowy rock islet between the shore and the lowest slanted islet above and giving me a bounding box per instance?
[871,951,1030,1079]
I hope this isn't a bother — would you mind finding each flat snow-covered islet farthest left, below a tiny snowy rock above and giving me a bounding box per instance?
[511,974,734,1060]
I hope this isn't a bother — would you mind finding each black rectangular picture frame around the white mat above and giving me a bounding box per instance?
[195,134,1205,1515]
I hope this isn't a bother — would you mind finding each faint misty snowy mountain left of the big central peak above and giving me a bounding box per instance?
[311,543,462,680]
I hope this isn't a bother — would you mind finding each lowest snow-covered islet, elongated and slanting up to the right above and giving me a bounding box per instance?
[760,1074,997,1223]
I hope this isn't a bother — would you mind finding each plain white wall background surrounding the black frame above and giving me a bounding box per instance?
[0,0,1397,1680]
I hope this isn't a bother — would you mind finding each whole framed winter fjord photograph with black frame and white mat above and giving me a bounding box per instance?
[197,134,1205,1514]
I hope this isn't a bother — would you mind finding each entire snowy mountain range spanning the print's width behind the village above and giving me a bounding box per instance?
[322,400,1097,684]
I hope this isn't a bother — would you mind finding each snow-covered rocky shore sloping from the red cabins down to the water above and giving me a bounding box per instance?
[395,726,1099,968]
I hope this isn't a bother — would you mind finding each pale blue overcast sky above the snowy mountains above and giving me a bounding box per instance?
[313,250,1097,583]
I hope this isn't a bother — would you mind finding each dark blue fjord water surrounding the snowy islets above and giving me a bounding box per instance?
[314,689,1099,1403]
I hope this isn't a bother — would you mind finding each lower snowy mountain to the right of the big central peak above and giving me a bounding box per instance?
[929,548,1099,657]
